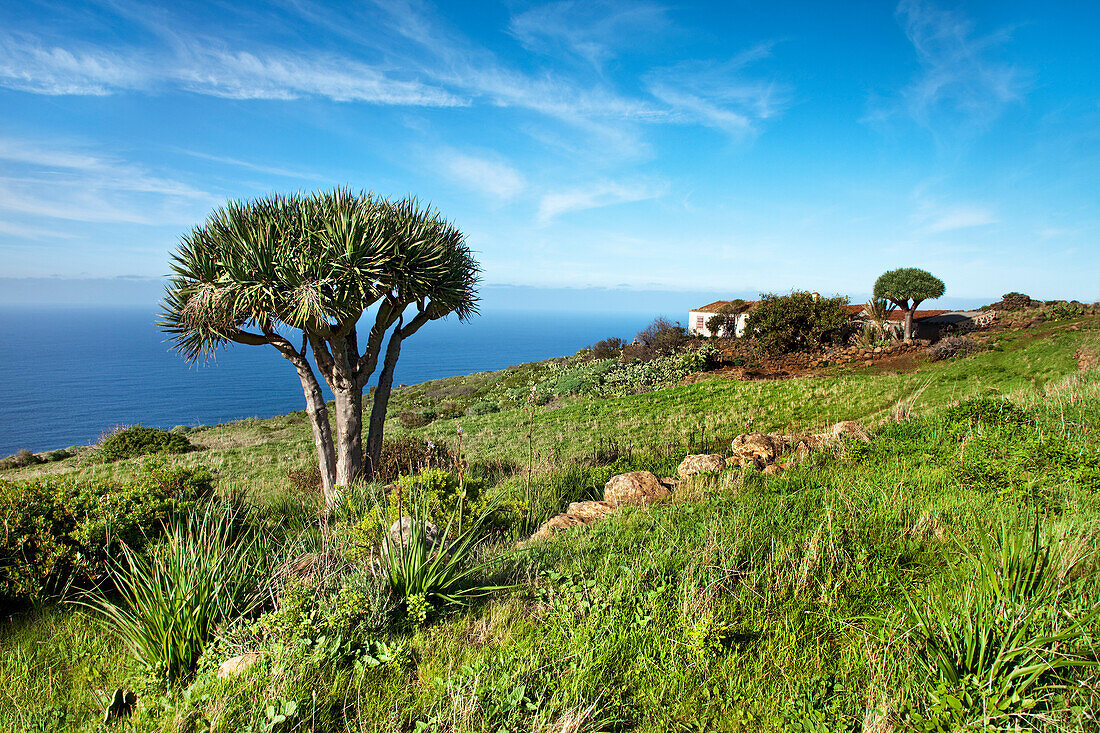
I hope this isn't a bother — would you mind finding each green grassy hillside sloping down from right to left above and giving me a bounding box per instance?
[0,318,1100,732]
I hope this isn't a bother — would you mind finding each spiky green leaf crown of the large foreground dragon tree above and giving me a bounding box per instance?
[160,188,480,361]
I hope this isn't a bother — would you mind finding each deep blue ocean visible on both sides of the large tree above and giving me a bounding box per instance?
[0,306,656,457]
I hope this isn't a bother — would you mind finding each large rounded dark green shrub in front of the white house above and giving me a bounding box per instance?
[746,291,855,353]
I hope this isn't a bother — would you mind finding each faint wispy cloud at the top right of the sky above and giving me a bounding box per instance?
[869,0,1027,125]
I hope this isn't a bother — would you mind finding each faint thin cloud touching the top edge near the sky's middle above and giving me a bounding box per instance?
[508,0,671,67]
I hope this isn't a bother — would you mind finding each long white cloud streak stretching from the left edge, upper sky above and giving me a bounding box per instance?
[0,34,466,107]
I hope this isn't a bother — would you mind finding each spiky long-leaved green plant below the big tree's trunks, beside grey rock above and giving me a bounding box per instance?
[382,490,509,624]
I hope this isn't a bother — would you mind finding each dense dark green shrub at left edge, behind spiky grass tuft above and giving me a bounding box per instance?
[0,462,213,600]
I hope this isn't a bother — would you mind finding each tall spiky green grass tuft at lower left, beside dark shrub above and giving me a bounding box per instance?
[79,502,273,686]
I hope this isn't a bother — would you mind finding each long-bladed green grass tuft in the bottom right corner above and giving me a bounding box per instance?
[909,521,1100,731]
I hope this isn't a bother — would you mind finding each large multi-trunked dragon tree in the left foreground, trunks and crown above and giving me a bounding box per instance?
[158,188,481,510]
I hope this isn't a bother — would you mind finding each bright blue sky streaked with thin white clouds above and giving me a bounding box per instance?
[0,0,1100,302]
